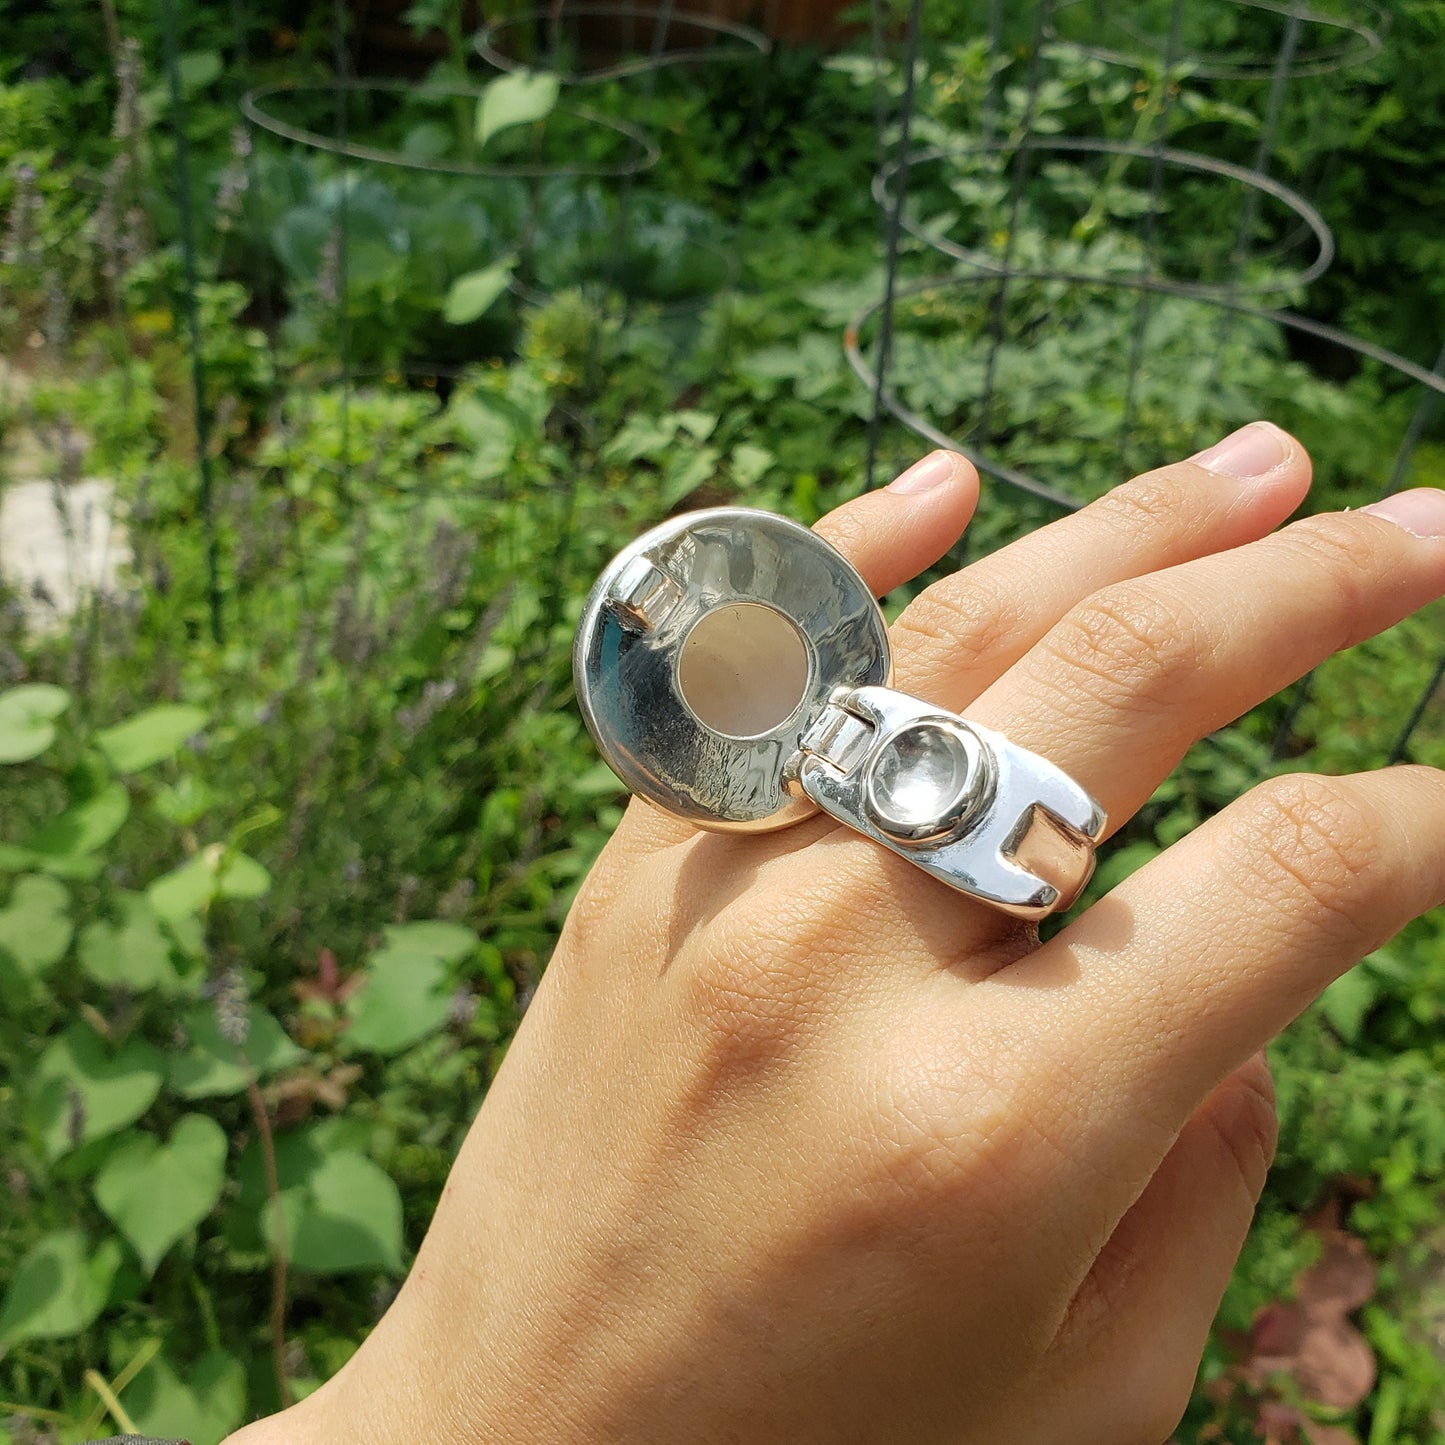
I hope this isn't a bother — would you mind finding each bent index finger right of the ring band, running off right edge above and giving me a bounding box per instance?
[1005,766,1445,1218]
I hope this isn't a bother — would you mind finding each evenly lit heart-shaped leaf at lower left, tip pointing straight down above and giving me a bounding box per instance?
[95,1114,225,1274]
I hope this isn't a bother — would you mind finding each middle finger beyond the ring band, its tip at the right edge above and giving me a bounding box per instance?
[970,491,1445,828]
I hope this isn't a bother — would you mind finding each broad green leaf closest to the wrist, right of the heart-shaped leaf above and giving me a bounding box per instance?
[262,1149,402,1274]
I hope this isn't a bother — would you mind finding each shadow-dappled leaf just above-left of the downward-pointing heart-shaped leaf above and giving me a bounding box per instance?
[26,1023,165,1159]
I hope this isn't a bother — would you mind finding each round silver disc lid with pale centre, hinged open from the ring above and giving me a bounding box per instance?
[572,507,890,831]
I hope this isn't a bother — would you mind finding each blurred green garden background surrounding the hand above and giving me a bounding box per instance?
[0,0,1445,1445]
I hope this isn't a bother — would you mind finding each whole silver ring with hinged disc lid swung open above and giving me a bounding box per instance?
[572,507,1105,919]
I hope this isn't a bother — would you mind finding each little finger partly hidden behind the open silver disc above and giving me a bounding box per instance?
[618,451,978,850]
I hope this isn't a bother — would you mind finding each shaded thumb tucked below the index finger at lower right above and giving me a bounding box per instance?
[1051,1053,1279,1439]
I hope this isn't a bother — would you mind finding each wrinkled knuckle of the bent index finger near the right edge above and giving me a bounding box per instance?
[1241,773,1380,936]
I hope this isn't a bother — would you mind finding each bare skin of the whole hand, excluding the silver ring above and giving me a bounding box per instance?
[219,428,1445,1445]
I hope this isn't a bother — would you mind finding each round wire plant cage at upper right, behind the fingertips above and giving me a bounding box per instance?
[844,0,1445,762]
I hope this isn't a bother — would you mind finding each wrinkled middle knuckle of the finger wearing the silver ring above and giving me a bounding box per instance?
[1046,584,1209,714]
